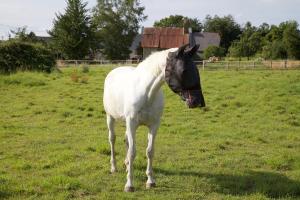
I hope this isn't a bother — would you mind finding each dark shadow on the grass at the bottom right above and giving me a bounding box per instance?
[154,168,300,198]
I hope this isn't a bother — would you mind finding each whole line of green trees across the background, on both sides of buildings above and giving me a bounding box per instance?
[2,0,300,60]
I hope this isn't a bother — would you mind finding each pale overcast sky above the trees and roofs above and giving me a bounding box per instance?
[0,0,300,39]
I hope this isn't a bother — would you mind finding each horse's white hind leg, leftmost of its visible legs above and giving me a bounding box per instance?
[106,115,117,173]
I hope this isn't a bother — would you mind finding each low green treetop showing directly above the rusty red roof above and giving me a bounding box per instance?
[154,15,203,32]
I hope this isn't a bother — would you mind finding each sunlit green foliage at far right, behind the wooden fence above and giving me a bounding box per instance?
[229,21,300,59]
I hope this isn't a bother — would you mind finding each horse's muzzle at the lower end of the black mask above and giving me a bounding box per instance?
[181,90,205,108]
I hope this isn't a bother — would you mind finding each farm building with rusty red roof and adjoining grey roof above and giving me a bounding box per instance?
[141,27,221,58]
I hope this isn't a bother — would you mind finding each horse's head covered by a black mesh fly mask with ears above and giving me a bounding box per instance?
[165,45,205,108]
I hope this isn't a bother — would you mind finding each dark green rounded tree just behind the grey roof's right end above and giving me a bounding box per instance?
[204,15,242,52]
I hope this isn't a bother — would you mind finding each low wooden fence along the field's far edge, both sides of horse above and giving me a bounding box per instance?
[57,60,300,70]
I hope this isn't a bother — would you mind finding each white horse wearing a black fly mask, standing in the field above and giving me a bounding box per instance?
[103,44,205,192]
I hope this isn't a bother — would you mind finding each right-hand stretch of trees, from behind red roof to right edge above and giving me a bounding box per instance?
[154,15,300,59]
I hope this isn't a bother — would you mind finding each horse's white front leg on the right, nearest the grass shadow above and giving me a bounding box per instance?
[146,122,159,189]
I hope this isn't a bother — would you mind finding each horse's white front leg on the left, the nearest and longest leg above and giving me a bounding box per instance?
[124,118,137,192]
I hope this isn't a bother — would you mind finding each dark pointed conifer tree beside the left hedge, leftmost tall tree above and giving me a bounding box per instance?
[48,0,92,59]
